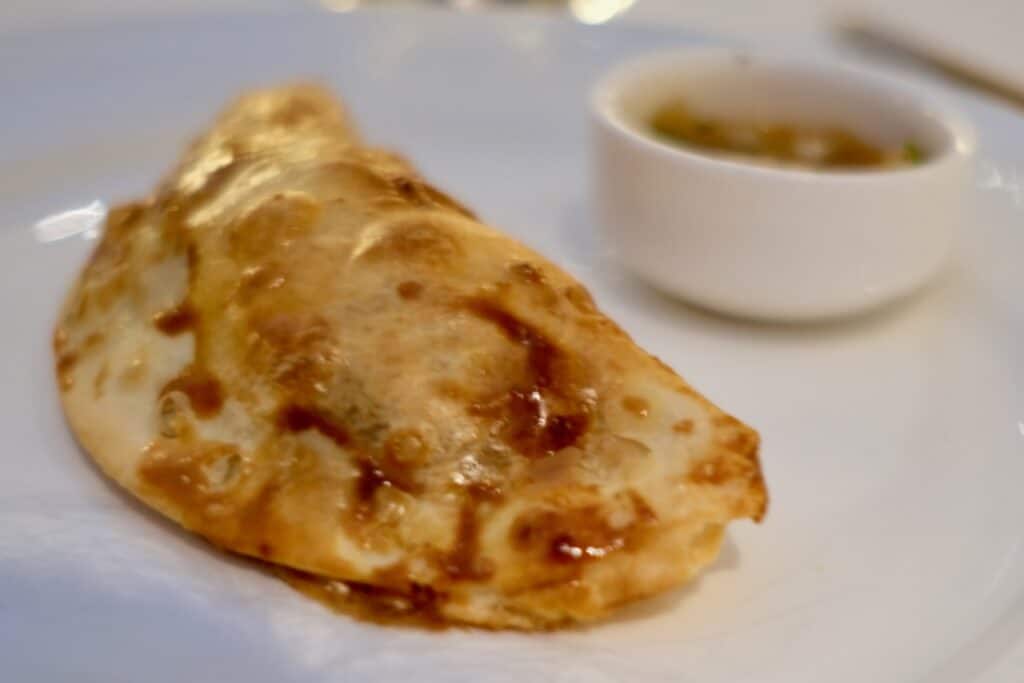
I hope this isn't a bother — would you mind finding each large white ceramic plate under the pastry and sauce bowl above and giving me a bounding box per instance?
[0,6,1024,683]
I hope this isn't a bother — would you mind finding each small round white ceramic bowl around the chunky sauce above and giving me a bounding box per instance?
[592,48,975,321]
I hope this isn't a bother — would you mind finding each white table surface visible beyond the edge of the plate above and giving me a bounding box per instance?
[0,0,1024,683]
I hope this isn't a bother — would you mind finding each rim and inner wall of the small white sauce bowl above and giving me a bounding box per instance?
[591,47,976,182]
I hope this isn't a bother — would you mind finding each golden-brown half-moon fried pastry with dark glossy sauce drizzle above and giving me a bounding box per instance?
[54,86,766,629]
